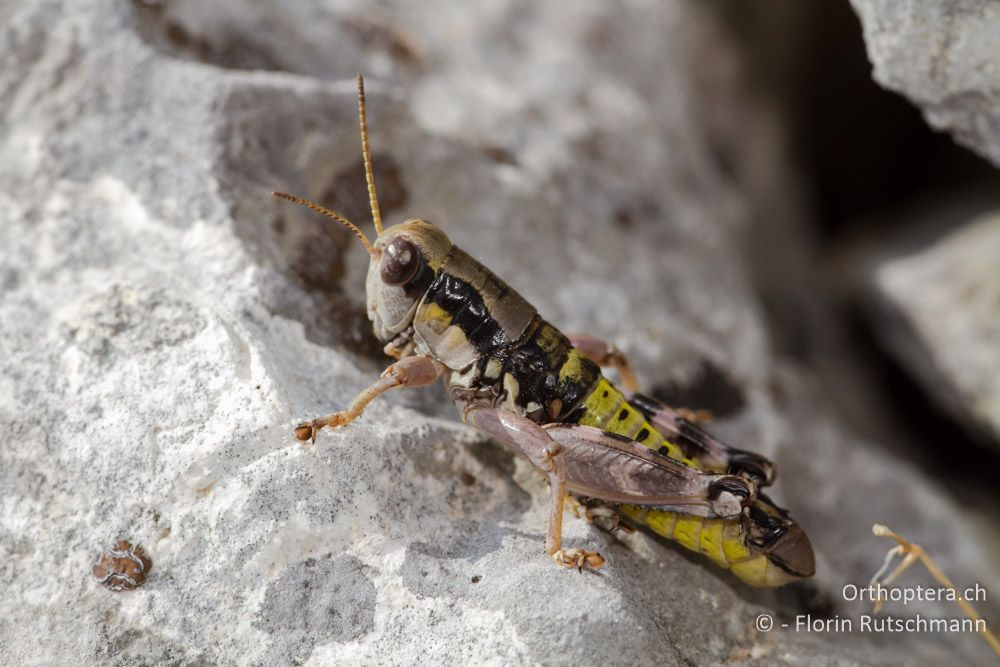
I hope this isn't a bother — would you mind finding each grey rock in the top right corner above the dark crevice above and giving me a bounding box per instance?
[851,0,1000,165]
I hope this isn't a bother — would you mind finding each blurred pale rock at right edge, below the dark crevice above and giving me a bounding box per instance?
[872,214,1000,445]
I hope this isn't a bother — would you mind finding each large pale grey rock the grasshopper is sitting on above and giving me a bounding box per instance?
[0,0,1000,665]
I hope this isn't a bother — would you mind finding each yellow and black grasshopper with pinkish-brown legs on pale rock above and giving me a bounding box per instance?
[273,75,814,586]
